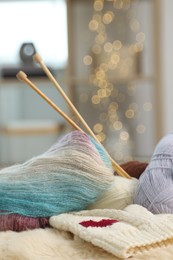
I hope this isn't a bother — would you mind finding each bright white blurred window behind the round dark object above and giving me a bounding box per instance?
[0,0,67,68]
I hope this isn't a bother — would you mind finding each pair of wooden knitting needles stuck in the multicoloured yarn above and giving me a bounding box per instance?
[16,53,131,179]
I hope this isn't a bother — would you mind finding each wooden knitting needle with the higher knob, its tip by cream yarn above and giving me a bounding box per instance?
[33,53,131,178]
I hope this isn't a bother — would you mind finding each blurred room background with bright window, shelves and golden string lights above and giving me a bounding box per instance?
[0,0,173,165]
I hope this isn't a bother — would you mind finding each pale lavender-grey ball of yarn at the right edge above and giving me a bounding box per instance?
[134,133,173,214]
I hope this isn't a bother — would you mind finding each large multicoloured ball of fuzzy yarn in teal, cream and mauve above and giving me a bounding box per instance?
[0,131,113,217]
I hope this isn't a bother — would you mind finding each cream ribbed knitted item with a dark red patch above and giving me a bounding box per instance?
[50,205,173,258]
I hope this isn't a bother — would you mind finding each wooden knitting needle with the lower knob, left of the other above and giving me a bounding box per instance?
[16,71,84,132]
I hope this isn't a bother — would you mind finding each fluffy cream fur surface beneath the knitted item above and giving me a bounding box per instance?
[0,222,173,260]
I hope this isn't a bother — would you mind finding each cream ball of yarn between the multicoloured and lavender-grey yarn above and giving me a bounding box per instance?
[87,176,138,209]
